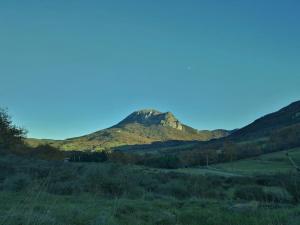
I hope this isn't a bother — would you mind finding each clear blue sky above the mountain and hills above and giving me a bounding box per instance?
[0,0,300,139]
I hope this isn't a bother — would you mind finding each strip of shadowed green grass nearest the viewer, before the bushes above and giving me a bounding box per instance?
[0,192,300,225]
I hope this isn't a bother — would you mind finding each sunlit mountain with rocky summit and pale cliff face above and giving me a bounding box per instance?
[28,109,230,151]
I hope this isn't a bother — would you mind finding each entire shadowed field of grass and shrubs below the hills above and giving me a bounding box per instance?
[0,149,300,225]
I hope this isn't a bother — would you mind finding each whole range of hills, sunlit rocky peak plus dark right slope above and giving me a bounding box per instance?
[27,101,300,161]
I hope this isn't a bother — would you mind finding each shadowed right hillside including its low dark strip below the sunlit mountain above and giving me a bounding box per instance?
[98,101,300,158]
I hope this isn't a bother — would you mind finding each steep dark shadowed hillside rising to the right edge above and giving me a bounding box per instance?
[179,101,300,158]
